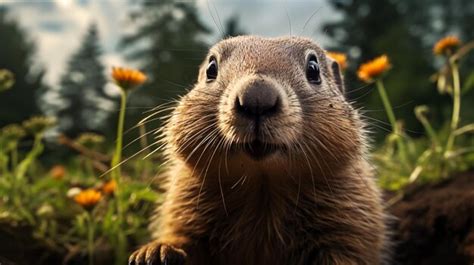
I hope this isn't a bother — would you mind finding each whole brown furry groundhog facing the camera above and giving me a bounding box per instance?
[129,36,388,265]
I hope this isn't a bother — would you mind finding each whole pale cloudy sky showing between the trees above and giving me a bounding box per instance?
[0,0,339,86]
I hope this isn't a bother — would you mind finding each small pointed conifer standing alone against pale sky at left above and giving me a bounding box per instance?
[56,24,111,136]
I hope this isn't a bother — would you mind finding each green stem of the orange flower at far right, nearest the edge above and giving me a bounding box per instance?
[444,59,461,157]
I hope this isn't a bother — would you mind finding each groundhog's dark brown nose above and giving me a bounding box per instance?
[235,80,280,119]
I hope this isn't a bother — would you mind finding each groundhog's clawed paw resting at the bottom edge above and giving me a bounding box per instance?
[128,242,186,265]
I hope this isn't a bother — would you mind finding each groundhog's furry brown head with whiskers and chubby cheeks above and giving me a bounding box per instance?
[165,36,364,177]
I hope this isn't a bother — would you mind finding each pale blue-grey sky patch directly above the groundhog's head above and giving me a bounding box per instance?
[197,0,339,44]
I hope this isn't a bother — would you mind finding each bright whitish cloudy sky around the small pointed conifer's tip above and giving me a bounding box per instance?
[0,0,129,85]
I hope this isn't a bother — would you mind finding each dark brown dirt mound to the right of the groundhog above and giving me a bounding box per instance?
[389,170,474,265]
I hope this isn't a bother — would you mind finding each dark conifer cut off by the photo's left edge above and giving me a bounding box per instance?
[0,6,44,127]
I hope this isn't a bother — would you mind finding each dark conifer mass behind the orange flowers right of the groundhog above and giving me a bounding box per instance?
[322,0,474,132]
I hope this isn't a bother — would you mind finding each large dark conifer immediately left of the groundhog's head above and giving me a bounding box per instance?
[122,0,209,105]
